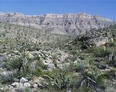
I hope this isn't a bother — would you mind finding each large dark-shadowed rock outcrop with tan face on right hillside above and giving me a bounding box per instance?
[75,31,109,47]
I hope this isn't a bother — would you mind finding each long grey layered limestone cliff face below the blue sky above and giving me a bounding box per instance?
[0,12,113,35]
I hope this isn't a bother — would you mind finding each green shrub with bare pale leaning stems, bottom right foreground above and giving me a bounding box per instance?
[78,67,104,92]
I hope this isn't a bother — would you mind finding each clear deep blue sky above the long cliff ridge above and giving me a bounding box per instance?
[0,0,116,20]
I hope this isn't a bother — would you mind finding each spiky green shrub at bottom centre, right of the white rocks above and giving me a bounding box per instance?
[44,70,72,89]
